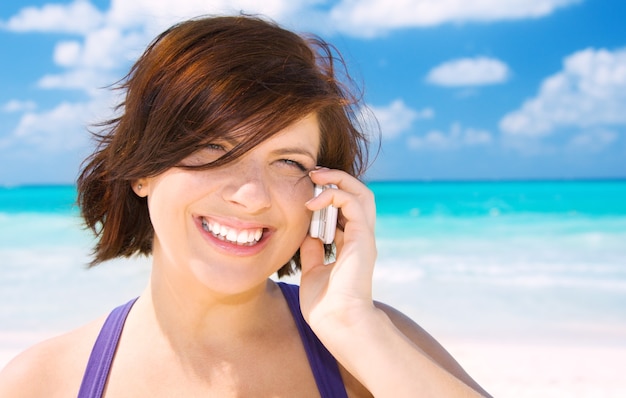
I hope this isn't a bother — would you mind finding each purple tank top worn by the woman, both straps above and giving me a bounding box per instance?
[78,282,348,398]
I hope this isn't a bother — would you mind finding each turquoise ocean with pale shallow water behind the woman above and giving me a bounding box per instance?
[0,180,626,349]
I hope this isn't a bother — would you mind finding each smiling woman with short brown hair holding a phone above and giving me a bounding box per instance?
[0,16,488,398]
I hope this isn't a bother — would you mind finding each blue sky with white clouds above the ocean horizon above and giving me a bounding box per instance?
[0,0,626,185]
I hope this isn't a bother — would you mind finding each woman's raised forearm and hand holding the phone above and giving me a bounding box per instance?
[300,169,487,398]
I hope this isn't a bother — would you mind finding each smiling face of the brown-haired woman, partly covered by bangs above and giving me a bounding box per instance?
[141,114,320,293]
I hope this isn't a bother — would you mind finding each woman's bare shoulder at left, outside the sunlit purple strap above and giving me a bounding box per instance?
[0,318,104,398]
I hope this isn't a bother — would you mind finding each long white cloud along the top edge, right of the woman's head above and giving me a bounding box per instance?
[330,0,582,37]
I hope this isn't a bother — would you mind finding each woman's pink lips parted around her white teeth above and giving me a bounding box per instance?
[194,215,274,257]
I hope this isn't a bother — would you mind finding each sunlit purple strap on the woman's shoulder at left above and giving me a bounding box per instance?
[78,298,137,398]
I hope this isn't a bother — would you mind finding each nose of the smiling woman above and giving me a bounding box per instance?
[222,161,272,214]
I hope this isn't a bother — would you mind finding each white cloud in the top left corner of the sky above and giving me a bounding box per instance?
[3,0,104,34]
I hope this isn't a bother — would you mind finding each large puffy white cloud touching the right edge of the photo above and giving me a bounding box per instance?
[500,48,626,136]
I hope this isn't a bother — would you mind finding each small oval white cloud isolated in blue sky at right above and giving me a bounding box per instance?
[426,57,510,86]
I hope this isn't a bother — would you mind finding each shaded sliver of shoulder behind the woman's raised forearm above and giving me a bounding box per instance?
[376,302,489,396]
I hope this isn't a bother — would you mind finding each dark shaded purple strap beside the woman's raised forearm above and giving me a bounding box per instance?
[278,282,348,398]
